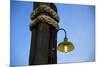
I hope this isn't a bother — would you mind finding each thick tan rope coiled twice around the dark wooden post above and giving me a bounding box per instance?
[30,5,59,30]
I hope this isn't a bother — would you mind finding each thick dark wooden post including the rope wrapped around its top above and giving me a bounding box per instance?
[29,2,59,65]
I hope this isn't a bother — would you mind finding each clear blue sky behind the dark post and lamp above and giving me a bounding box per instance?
[10,1,95,65]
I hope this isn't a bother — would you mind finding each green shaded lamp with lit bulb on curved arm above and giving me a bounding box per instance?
[57,28,75,53]
